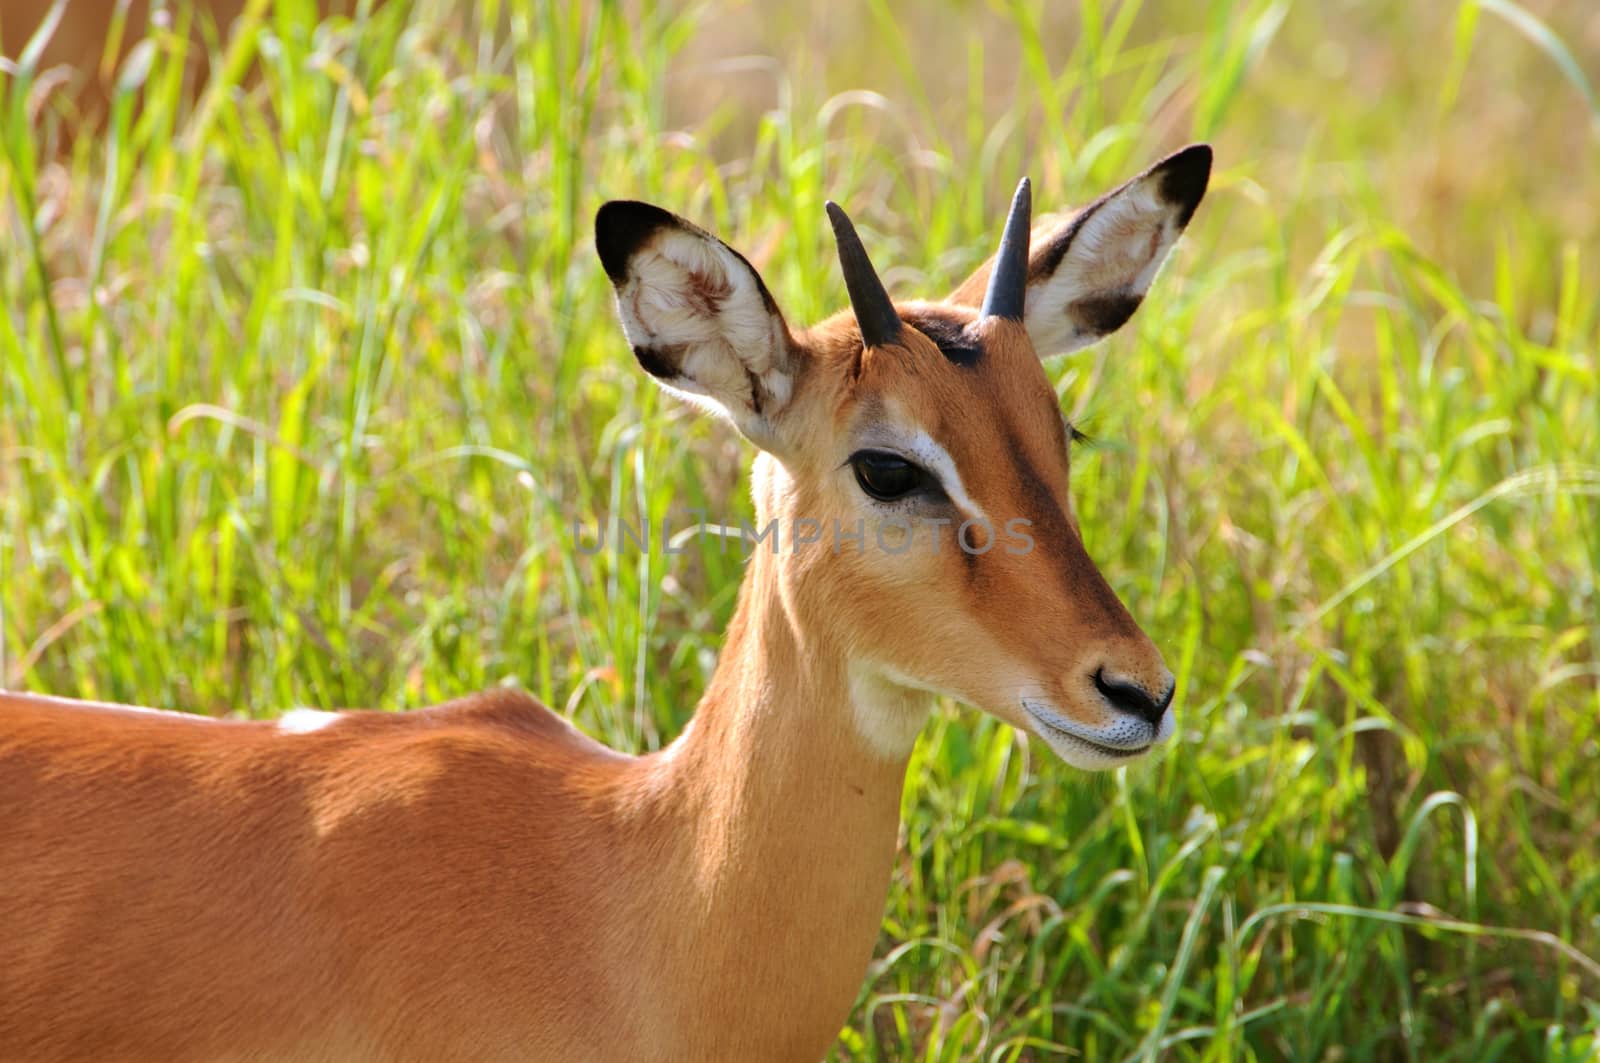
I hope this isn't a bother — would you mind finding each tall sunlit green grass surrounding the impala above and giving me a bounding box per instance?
[0,0,1600,1063]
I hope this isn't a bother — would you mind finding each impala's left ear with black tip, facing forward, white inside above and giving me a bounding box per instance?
[595,200,797,450]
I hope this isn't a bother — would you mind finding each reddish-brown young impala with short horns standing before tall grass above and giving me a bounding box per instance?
[0,146,1211,1061]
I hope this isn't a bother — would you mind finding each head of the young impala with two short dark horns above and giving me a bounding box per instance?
[595,146,1211,768]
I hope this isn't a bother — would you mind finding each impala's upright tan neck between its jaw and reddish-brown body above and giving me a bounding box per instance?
[636,521,928,1058]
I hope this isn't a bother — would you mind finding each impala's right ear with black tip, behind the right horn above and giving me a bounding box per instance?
[950,144,1211,357]
